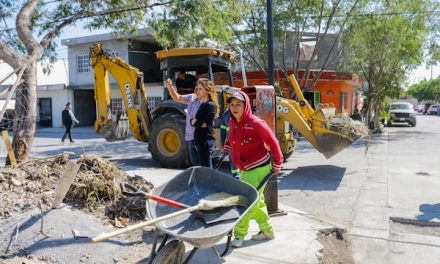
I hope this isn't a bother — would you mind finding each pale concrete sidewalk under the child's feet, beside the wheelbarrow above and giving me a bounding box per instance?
[187,204,333,264]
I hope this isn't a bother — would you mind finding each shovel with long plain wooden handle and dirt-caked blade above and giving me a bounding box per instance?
[91,192,248,243]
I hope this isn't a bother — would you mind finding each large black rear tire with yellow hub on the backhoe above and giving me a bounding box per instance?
[148,113,191,168]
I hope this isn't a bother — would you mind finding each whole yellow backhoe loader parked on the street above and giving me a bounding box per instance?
[90,44,358,168]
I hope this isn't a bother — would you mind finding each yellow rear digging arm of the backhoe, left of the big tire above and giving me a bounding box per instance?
[90,44,151,142]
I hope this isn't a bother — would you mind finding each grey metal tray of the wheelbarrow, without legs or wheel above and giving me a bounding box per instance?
[146,167,258,248]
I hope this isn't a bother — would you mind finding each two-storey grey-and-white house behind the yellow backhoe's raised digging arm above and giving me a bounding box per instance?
[61,29,163,125]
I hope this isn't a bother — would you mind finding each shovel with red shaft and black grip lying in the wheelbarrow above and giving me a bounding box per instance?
[120,183,240,224]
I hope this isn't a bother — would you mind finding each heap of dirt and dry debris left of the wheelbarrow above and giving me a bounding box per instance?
[0,153,153,227]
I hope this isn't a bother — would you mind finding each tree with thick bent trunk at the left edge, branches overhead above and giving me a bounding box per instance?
[0,0,162,162]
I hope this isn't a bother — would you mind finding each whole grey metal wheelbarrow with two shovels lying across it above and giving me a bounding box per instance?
[146,167,270,263]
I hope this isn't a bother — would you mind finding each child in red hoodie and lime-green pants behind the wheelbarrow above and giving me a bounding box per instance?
[224,91,283,247]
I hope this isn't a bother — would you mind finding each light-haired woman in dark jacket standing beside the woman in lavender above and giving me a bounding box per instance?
[191,79,219,168]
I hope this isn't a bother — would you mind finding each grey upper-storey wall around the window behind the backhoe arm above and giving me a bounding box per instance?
[68,40,128,87]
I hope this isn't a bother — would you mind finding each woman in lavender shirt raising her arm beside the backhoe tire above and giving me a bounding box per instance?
[165,79,201,166]
